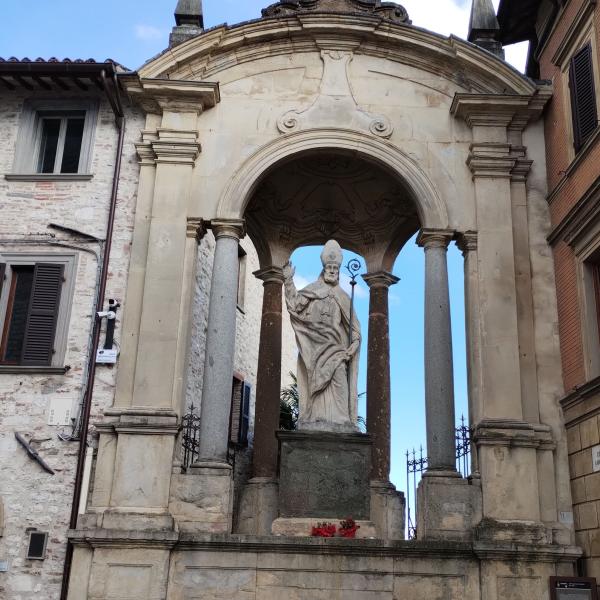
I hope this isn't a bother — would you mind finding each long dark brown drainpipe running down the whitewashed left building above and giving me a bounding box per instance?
[60,70,125,600]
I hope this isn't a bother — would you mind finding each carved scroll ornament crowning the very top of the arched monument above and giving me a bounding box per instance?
[262,0,411,25]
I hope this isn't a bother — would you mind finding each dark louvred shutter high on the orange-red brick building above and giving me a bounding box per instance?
[569,44,598,150]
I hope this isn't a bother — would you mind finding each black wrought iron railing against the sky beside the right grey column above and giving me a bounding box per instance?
[406,415,471,540]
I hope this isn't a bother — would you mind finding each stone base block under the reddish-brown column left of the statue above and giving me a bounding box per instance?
[235,477,279,535]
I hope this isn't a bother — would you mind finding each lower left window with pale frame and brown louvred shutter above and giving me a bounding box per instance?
[0,255,75,367]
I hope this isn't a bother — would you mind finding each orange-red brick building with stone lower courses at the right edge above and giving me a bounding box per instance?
[498,0,600,578]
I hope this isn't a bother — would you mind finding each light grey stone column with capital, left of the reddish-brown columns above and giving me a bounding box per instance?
[198,220,244,467]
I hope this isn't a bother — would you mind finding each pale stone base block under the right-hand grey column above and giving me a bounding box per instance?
[417,471,481,541]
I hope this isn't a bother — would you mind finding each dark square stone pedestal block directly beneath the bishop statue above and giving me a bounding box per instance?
[277,431,371,522]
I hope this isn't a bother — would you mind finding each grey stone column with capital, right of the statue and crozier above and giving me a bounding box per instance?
[418,230,456,474]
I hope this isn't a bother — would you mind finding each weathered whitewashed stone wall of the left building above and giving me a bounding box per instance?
[0,92,143,600]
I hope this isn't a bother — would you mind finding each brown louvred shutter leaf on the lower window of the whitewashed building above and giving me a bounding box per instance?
[21,263,65,366]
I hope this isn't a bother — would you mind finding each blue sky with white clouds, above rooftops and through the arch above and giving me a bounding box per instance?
[0,0,527,502]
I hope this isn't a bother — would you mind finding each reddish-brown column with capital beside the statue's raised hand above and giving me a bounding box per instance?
[253,267,283,479]
